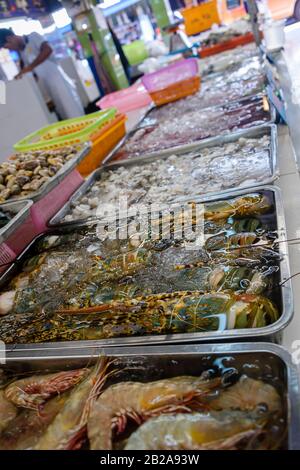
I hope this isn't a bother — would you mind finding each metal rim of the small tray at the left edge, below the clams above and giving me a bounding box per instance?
[0,199,33,243]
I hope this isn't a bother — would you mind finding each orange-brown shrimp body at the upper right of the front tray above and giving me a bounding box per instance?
[209,375,281,412]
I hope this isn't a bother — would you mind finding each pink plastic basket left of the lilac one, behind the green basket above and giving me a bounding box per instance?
[96,83,152,113]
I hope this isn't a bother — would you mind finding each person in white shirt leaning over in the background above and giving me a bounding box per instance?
[0,29,84,119]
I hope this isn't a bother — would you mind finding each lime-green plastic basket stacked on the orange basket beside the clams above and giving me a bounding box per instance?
[14,108,117,152]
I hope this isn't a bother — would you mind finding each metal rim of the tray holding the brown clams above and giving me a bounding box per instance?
[2,142,91,203]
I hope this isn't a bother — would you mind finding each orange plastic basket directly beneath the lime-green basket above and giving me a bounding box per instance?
[77,113,126,176]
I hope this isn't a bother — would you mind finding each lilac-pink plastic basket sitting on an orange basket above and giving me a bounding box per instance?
[142,59,198,93]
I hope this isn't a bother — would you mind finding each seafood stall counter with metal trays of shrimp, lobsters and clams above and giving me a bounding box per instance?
[0,17,300,452]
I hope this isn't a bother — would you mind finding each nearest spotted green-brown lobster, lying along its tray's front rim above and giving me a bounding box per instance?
[0,291,279,343]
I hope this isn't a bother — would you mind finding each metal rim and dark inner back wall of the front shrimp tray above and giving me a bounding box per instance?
[2,343,300,450]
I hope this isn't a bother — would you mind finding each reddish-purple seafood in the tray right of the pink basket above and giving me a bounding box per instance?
[113,95,270,160]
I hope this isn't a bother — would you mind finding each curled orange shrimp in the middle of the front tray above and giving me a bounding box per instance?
[88,376,221,450]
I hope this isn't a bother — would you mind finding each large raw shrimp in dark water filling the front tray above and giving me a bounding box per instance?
[0,352,289,450]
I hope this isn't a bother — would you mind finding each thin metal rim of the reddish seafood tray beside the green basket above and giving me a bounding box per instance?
[103,93,277,164]
